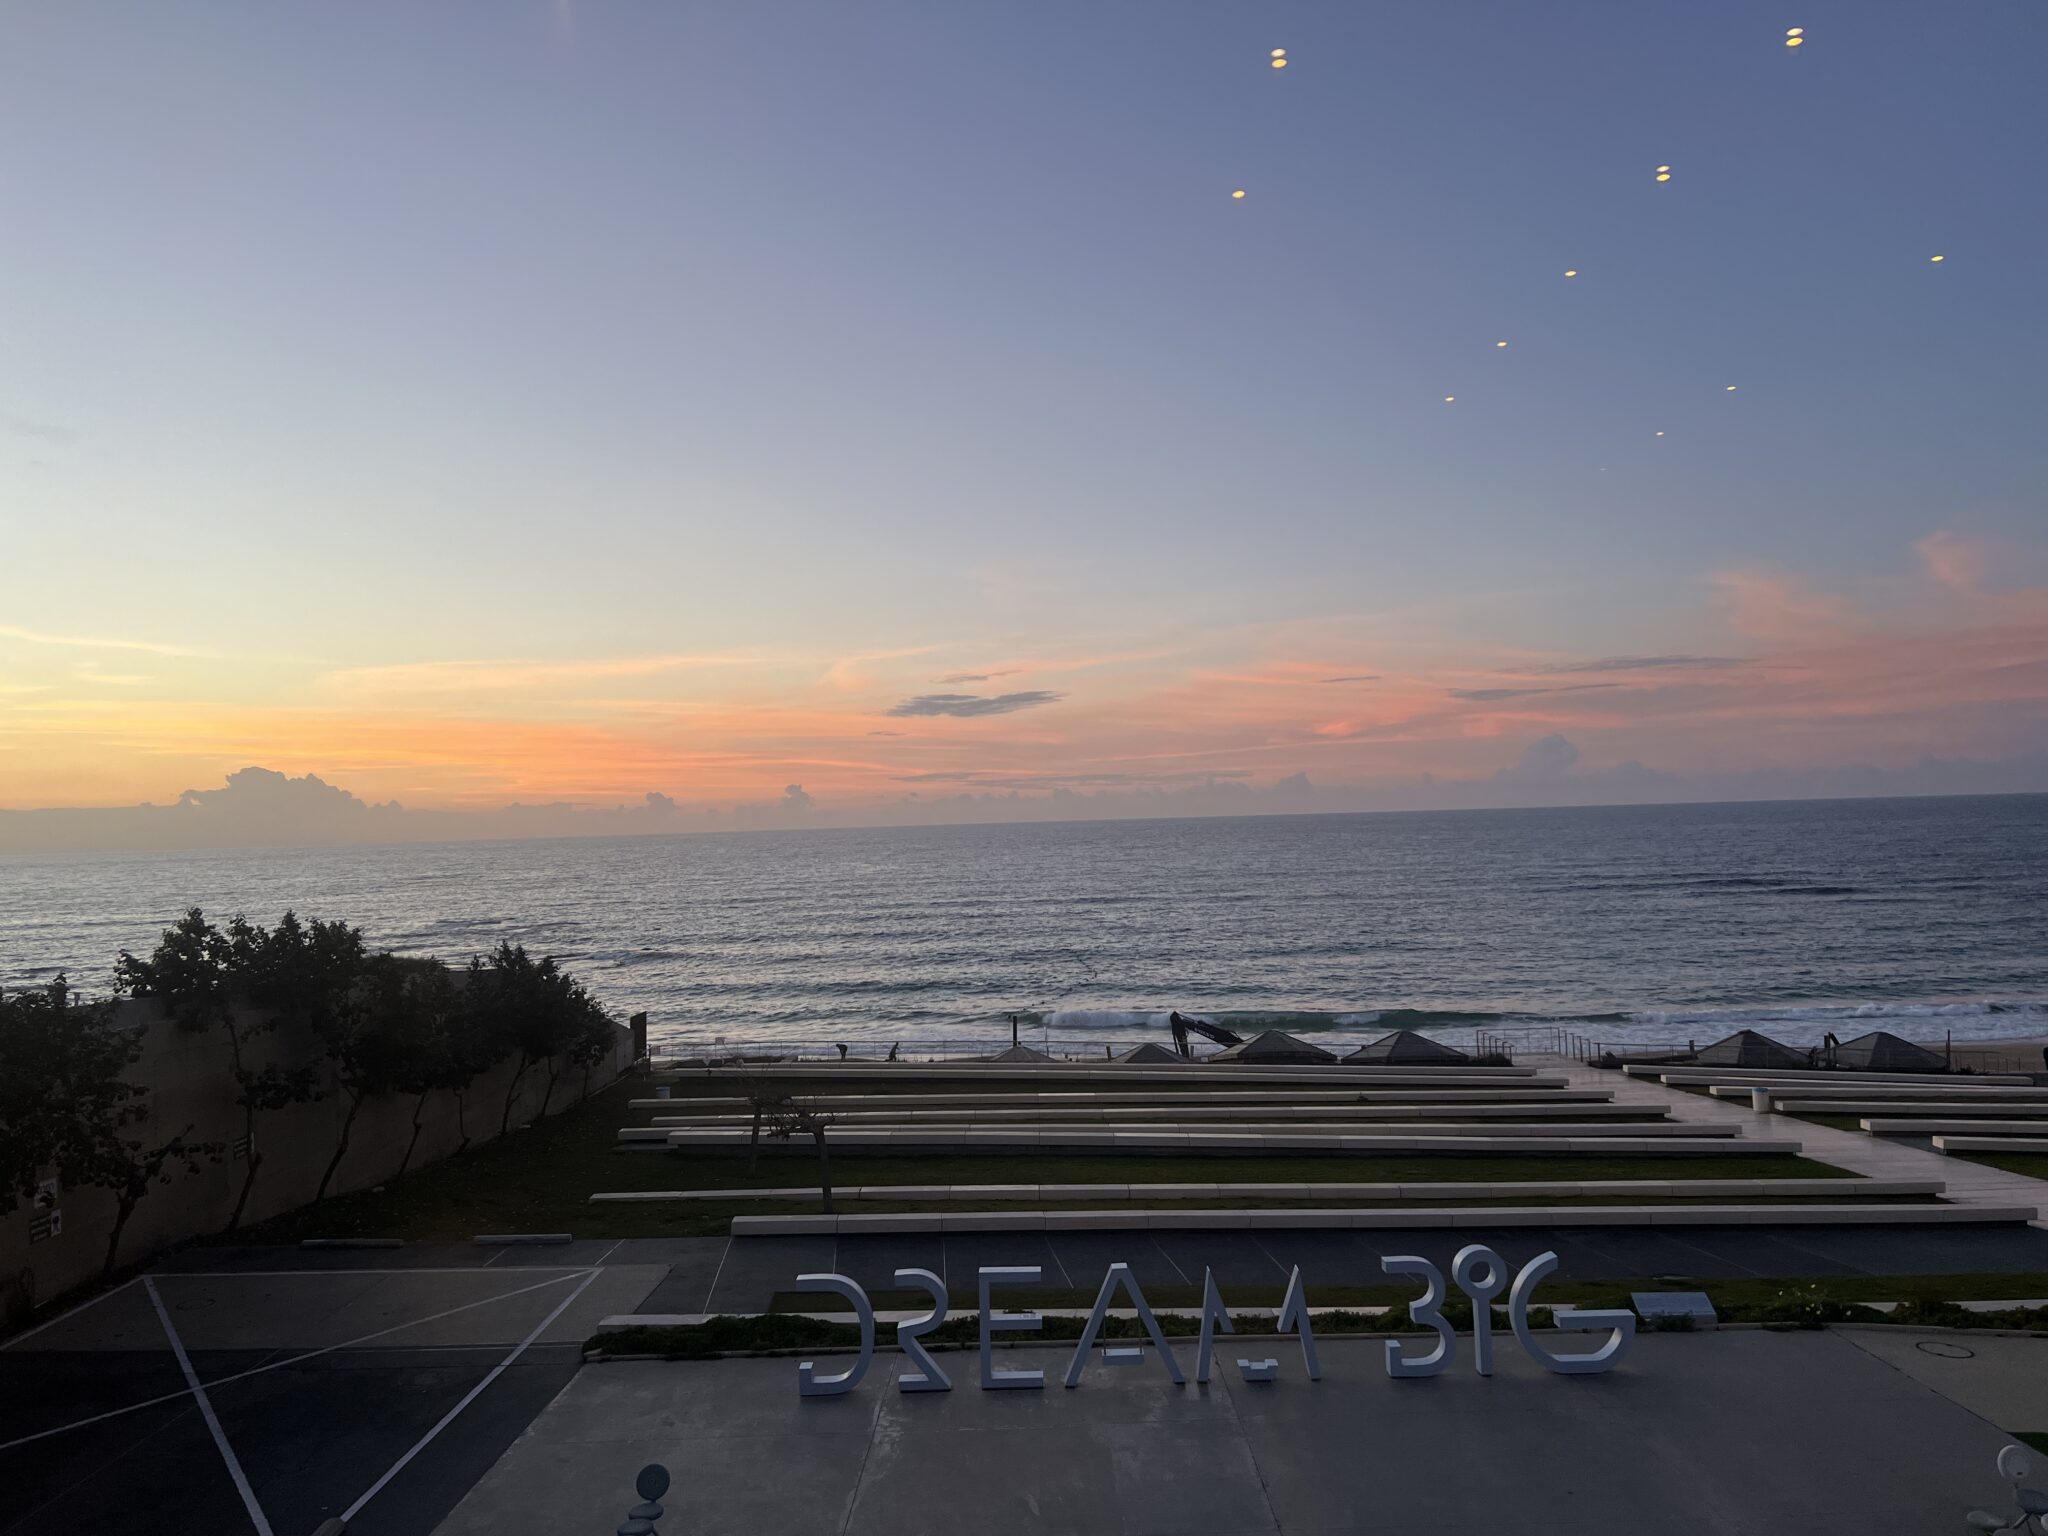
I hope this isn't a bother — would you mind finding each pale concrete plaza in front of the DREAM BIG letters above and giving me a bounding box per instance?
[440,1331,2048,1536]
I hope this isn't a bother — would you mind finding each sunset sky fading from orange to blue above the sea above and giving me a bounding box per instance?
[0,0,2048,847]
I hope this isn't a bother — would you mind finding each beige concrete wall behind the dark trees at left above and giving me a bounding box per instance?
[0,999,633,1321]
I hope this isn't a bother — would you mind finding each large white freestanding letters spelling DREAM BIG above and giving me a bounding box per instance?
[797,1243,1636,1397]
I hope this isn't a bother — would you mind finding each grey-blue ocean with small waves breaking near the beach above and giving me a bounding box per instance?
[0,795,2048,1055]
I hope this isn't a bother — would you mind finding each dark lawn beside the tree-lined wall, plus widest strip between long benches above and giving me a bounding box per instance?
[216,1079,1867,1243]
